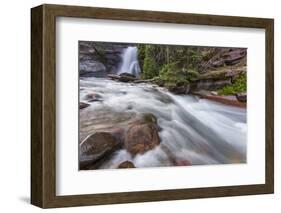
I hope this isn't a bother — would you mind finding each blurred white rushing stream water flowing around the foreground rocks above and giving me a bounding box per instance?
[80,78,247,168]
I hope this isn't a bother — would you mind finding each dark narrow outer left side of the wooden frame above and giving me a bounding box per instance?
[31,6,44,207]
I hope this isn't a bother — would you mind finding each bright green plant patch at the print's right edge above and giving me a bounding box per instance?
[218,74,247,95]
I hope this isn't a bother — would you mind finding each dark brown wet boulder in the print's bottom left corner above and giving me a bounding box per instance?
[79,132,121,169]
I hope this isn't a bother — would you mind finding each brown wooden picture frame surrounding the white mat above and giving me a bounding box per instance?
[31,4,274,208]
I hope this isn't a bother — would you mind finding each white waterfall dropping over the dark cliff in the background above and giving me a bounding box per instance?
[118,47,141,78]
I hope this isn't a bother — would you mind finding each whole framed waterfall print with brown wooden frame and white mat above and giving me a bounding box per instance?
[31,5,274,208]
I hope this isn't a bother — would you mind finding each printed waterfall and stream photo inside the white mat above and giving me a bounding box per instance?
[79,42,247,170]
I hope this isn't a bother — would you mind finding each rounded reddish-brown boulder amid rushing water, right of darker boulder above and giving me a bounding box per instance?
[124,114,160,155]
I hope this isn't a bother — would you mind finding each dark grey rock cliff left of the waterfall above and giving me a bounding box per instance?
[79,41,129,77]
